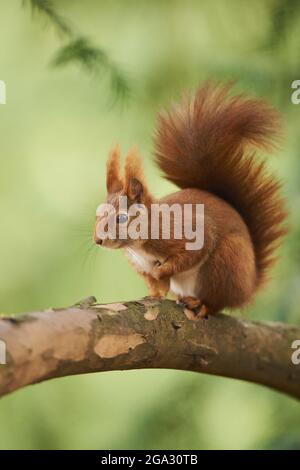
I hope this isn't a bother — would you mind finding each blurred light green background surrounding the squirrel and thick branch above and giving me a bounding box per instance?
[0,0,300,449]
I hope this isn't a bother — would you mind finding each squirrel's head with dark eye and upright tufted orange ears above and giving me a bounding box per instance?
[93,146,152,248]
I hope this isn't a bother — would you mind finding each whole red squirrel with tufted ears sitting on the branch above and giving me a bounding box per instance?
[94,82,286,317]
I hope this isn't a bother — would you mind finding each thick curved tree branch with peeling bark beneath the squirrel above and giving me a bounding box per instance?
[0,298,300,398]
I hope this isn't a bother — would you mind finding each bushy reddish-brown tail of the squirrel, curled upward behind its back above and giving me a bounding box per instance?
[155,83,286,286]
